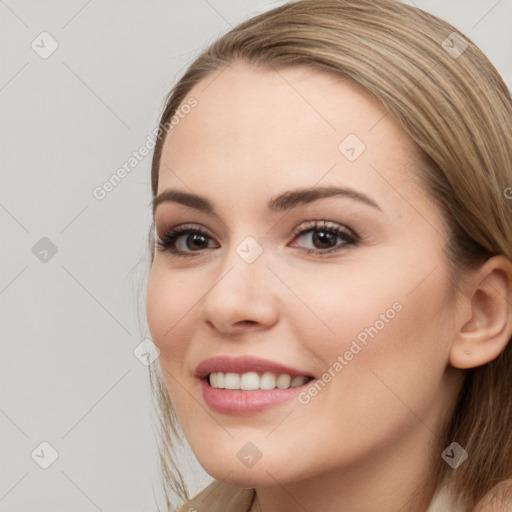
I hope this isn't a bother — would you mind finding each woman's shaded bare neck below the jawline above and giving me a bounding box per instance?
[249,425,440,512]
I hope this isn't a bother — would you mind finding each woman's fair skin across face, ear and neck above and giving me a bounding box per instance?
[147,63,511,512]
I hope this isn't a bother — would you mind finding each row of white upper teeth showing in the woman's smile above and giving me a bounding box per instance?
[209,372,309,391]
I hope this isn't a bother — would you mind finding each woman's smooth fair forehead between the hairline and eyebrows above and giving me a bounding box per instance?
[158,62,430,220]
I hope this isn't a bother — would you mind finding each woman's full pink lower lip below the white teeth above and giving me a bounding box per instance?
[200,379,310,415]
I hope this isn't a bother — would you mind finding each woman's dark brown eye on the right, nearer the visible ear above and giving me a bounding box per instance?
[292,220,359,254]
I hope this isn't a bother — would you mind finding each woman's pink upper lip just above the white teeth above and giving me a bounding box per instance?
[195,356,311,379]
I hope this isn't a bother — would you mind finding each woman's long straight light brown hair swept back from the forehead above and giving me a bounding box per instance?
[143,0,512,511]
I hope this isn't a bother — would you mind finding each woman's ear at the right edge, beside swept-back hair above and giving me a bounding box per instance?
[450,256,512,369]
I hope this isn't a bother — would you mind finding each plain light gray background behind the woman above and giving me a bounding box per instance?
[0,0,512,512]
